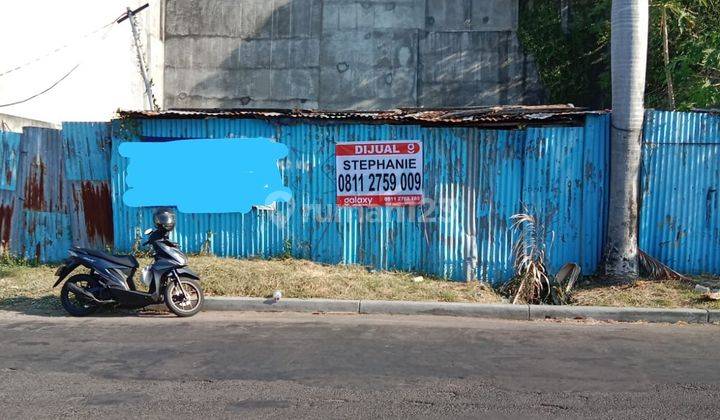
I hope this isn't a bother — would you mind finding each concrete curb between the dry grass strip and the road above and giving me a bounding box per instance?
[197,297,720,323]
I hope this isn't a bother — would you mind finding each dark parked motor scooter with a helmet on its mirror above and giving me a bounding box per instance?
[53,209,204,317]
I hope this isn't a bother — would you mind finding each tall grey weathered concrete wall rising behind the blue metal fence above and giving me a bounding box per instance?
[158,0,540,109]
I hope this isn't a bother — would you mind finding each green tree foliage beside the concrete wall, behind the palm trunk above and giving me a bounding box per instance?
[519,0,720,109]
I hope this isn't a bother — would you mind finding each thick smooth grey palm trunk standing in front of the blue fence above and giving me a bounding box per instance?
[604,0,649,279]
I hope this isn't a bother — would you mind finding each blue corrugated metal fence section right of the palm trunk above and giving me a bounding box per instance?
[640,111,720,274]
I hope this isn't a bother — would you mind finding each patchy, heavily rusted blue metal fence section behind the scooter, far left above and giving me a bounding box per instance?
[0,123,113,262]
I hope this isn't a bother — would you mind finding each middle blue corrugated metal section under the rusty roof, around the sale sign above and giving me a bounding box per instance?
[111,114,609,281]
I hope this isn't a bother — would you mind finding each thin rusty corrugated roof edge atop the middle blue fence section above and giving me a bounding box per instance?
[118,105,605,127]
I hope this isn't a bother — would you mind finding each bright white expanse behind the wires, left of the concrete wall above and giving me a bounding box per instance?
[0,0,147,123]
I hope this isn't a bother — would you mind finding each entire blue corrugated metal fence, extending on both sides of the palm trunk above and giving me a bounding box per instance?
[0,111,720,281]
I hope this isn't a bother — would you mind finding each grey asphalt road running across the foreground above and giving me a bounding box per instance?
[0,312,720,419]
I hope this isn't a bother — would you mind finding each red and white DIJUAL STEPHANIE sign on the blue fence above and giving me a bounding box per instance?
[335,141,423,207]
